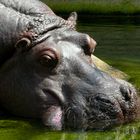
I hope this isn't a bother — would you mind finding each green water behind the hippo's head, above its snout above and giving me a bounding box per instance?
[78,22,140,88]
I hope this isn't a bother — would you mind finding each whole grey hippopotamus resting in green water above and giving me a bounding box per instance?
[0,0,137,130]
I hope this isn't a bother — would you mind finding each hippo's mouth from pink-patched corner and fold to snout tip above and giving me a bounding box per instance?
[43,88,135,130]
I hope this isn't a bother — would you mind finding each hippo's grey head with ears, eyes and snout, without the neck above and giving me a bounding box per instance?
[0,12,136,130]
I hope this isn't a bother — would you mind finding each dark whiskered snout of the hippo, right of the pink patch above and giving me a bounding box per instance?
[61,81,137,130]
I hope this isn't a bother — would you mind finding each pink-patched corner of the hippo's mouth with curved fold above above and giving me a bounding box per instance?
[42,89,64,130]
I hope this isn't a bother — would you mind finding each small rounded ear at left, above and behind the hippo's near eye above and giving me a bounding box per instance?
[15,38,31,51]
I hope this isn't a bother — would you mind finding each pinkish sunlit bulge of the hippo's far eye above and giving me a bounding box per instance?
[87,35,97,54]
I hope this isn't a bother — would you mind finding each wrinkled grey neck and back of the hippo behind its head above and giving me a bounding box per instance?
[0,0,75,63]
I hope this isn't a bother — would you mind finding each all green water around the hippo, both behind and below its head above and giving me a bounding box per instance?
[0,20,140,140]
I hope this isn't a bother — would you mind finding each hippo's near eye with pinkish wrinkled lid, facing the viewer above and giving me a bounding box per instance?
[39,50,58,69]
